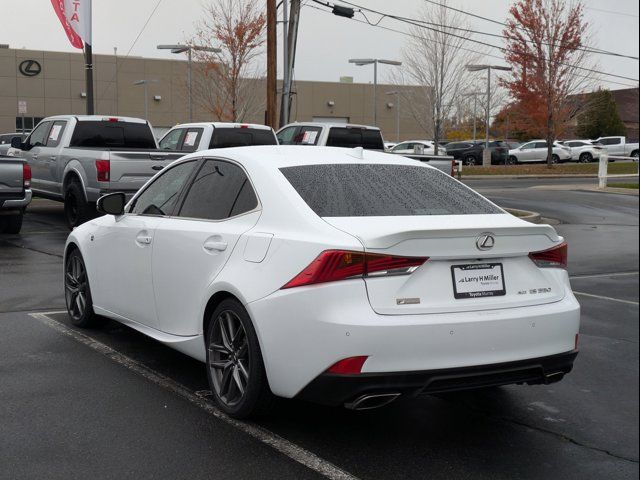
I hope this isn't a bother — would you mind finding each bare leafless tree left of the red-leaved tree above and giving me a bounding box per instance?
[404,0,478,153]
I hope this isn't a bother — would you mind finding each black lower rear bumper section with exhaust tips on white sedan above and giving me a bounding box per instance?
[296,350,578,406]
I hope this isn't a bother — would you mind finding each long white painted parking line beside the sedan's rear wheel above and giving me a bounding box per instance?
[29,311,358,480]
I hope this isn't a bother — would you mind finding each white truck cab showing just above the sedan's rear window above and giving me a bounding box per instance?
[277,122,385,152]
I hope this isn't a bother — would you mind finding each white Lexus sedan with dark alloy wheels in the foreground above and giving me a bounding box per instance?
[64,146,580,418]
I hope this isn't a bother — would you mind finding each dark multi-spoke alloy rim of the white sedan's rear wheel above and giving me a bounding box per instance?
[209,310,251,406]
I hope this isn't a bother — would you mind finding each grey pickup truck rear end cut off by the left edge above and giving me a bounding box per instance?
[0,156,31,233]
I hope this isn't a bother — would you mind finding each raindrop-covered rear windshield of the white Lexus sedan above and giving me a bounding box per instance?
[280,164,502,217]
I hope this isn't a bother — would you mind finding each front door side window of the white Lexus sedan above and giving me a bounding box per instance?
[130,161,196,216]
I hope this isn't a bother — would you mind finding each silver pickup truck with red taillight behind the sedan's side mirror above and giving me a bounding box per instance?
[12,115,184,228]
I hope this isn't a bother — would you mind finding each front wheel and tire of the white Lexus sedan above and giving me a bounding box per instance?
[64,249,101,328]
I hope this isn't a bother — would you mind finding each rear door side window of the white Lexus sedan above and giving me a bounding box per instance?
[179,160,258,220]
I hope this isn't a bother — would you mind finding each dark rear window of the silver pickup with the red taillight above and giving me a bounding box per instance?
[71,121,156,149]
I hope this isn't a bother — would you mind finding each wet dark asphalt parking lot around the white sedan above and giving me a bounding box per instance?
[0,180,639,479]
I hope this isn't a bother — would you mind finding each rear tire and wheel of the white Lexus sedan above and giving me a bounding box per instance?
[205,298,275,419]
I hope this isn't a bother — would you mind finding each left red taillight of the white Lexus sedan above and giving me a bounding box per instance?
[282,250,428,289]
